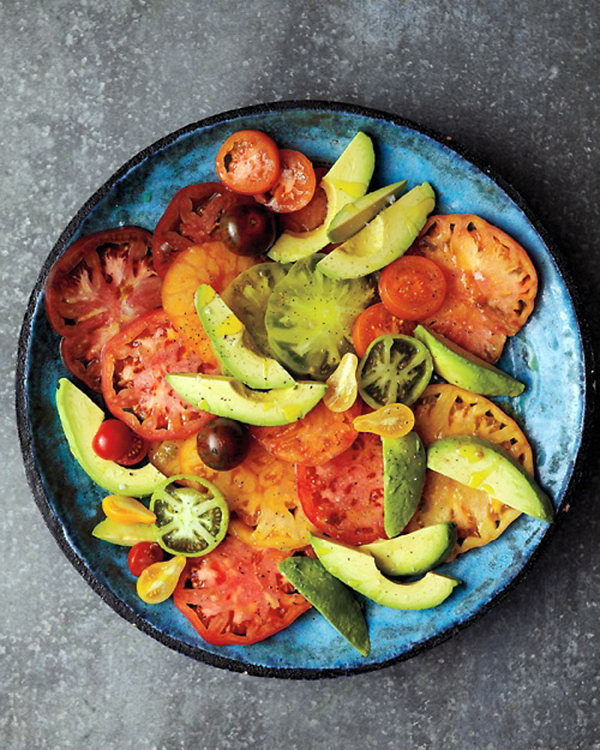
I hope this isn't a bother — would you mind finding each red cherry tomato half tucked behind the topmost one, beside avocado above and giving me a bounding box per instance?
[254,148,317,214]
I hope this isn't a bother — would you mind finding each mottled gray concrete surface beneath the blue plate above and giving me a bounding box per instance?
[0,0,600,750]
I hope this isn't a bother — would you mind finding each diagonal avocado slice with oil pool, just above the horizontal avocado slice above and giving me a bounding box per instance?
[194,284,295,389]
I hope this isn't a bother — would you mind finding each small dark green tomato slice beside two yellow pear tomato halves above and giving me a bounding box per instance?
[357,334,433,409]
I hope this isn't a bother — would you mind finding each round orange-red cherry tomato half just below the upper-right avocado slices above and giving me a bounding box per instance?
[379,255,446,320]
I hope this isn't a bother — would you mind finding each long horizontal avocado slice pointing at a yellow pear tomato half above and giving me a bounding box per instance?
[166,373,327,427]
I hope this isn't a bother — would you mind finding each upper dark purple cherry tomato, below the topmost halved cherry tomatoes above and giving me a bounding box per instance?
[219,203,277,256]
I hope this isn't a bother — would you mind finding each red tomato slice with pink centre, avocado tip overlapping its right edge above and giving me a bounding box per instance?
[102,310,213,440]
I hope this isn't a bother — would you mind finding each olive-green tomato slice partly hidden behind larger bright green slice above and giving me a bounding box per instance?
[221,263,289,357]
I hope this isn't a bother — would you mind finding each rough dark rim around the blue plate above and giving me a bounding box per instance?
[16,99,595,680]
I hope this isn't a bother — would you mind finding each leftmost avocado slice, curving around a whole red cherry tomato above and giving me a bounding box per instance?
[56,378,165,497]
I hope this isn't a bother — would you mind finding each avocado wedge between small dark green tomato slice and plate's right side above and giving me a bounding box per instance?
[413,325,525,396]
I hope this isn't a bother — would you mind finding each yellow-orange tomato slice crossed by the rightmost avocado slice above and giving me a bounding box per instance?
[405,385,533,557]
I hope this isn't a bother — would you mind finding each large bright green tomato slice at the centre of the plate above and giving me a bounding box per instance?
[265,253,375,380]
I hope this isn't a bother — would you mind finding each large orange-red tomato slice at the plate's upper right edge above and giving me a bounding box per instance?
[409,214,538,362]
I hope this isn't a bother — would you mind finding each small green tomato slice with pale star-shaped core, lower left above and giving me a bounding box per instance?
[150,474,229,557]
